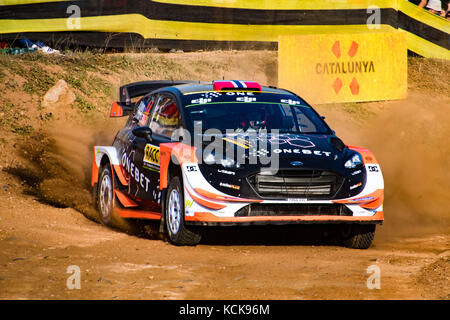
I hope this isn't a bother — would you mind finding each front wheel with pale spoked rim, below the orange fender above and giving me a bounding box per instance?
[164,176,201,246]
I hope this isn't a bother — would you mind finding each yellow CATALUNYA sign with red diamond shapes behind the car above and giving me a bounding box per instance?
[278,32,407,103]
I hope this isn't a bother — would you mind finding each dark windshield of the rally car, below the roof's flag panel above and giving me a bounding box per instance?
[181,92,328,134]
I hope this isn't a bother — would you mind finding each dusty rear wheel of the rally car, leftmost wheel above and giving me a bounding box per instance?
[97,165,115,226]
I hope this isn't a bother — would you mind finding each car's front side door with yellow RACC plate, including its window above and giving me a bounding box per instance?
[133,93,180,206]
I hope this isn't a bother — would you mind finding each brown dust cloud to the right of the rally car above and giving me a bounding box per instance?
[322,92,450,236]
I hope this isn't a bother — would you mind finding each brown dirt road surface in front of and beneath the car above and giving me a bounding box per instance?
[0,180,450,299]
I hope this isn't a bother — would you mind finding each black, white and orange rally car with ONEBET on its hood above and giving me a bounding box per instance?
[92,80,384,248]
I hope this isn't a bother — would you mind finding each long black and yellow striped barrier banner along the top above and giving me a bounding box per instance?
[0,0,450,60]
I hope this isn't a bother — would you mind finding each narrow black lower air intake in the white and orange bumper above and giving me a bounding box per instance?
[236,203,352,217]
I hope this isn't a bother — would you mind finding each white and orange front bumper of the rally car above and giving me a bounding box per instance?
[182,159,384,226]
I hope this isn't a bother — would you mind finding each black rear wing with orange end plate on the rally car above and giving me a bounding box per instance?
[109,80,196,117]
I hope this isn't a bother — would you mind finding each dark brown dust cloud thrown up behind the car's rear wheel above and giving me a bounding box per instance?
[8,117,123,220]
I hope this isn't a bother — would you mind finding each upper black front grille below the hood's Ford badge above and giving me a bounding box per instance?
[248,170,344,199]
